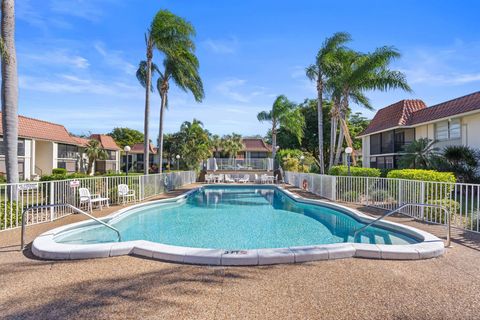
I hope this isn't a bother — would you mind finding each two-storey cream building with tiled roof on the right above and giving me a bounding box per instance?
[359,91,480,169]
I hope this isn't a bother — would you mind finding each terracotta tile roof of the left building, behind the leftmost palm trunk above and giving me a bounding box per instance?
[0,112,78,145]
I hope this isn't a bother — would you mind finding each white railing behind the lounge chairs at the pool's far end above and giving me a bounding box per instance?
[205,158,273,171]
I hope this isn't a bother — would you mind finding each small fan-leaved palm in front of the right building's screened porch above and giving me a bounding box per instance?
[399,138,438,169]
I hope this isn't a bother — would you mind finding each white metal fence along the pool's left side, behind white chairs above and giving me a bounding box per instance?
[0,171,196,231]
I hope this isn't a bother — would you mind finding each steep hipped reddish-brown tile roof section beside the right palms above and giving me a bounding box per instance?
[361,100,427,135]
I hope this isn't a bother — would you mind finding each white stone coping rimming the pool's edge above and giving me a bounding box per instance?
[32,184,445,266]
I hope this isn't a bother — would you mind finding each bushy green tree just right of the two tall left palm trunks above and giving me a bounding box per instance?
[175,119,212,169]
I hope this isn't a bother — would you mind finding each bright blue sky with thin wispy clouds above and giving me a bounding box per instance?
[16,0,480,136]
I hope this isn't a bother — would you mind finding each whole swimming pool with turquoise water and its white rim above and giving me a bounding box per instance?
[34,185,443,264]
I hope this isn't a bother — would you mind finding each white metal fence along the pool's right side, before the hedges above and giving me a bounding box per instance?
[284,172,480,232]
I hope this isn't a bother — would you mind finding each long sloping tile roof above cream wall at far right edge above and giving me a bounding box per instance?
[408,91,480,125]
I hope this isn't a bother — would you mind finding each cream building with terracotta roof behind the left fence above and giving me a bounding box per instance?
[0,113,120,180]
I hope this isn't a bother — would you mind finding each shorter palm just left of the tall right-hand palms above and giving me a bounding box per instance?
[257,95,305,159]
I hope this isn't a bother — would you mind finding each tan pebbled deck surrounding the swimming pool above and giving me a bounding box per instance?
[0,186,480,319]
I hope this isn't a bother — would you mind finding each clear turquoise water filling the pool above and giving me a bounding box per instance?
[55,186,416,249]
